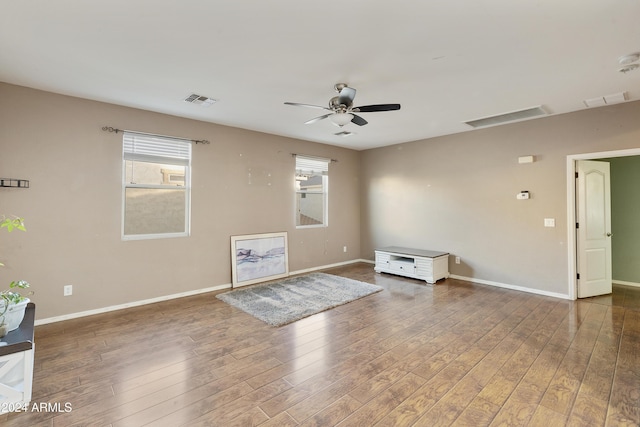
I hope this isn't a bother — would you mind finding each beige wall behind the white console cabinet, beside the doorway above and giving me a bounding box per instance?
[361,102,640,295]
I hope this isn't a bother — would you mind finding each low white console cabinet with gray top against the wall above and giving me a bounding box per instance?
[375,246,449,284]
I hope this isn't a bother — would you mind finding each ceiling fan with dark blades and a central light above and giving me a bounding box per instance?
[285,83,400,127]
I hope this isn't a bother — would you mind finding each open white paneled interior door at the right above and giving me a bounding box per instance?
[576,160,612,298]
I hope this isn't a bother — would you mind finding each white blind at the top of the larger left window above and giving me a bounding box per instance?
[122,132,191,166]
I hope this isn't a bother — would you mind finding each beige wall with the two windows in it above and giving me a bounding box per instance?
[0,83,360,319]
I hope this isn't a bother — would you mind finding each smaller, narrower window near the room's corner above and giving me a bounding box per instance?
[295,155,329,228]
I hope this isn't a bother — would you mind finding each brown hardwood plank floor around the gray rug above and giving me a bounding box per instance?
[0,263,640,427]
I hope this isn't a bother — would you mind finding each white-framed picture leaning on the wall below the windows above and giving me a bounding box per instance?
[231,231,289,288]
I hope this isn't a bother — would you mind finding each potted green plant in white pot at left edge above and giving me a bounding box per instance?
[0,215,30,337]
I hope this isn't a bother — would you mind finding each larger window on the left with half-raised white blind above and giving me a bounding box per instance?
[122,132,191,240]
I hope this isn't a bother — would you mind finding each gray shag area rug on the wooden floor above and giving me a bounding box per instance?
[216,273,382,326]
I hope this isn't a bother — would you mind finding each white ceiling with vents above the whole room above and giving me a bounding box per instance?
[0,0,640,150]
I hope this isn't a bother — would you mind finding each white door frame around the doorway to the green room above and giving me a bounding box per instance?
[567,148,640,300]
